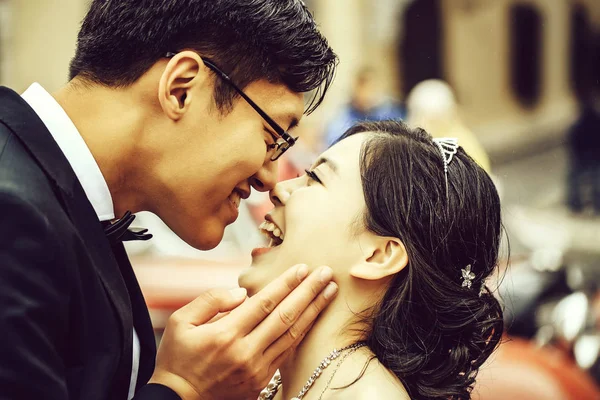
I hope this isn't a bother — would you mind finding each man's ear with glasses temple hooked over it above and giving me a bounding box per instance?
[158,51,208,121]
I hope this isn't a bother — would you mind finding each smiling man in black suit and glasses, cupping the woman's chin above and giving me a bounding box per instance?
[0,0,337,400]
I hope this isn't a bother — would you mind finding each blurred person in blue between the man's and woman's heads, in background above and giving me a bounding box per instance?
[324,67,404,147]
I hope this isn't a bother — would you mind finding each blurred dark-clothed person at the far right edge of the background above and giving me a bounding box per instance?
[567,95,600,214]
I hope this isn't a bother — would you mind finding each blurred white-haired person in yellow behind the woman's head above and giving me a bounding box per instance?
[406,79,490,172]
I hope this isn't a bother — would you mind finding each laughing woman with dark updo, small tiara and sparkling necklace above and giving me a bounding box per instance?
[239,121,503,400]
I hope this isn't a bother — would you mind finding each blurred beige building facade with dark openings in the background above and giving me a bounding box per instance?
[0,0,600,158]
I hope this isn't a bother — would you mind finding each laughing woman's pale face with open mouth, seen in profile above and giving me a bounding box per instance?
[239,133,368,295]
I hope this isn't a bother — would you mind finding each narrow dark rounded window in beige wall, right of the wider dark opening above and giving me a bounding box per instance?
[509,4,543,108]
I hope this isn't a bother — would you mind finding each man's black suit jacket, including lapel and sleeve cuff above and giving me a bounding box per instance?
[0,87,179,400]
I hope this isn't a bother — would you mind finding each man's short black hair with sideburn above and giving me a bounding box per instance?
[70,0,337,113]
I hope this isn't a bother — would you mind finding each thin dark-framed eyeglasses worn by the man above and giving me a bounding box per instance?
[165,52,298,161]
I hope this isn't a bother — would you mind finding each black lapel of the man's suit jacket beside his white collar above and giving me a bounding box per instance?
[0,87,133,398]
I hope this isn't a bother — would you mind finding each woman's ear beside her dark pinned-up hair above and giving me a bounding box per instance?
[350,233,408,281]
